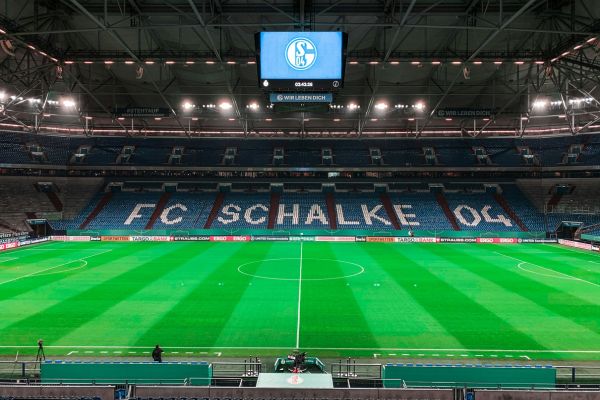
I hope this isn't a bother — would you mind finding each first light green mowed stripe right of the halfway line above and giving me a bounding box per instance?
[331,243,461,348]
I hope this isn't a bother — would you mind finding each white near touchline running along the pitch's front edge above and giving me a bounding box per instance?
[0,345,600,357]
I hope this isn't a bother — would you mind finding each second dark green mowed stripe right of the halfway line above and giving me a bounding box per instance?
[370,244,543,349]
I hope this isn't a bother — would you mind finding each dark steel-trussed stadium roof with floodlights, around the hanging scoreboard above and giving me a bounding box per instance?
[0,0,600,137]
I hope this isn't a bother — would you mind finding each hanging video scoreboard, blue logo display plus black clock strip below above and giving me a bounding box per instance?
[255,32,348,91]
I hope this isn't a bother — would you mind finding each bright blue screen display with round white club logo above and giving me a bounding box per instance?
[259,32,344,81]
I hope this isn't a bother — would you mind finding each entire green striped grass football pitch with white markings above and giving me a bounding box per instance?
[0,242,600,361]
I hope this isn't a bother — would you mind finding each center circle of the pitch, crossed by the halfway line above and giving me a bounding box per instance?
[237,257,365,281]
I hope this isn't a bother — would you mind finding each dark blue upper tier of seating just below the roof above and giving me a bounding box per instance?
[0,132,600,167]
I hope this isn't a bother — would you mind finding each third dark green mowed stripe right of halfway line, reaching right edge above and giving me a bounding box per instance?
[446,248,600,340]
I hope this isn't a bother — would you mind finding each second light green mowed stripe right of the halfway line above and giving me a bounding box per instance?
[415,244,600,349]
